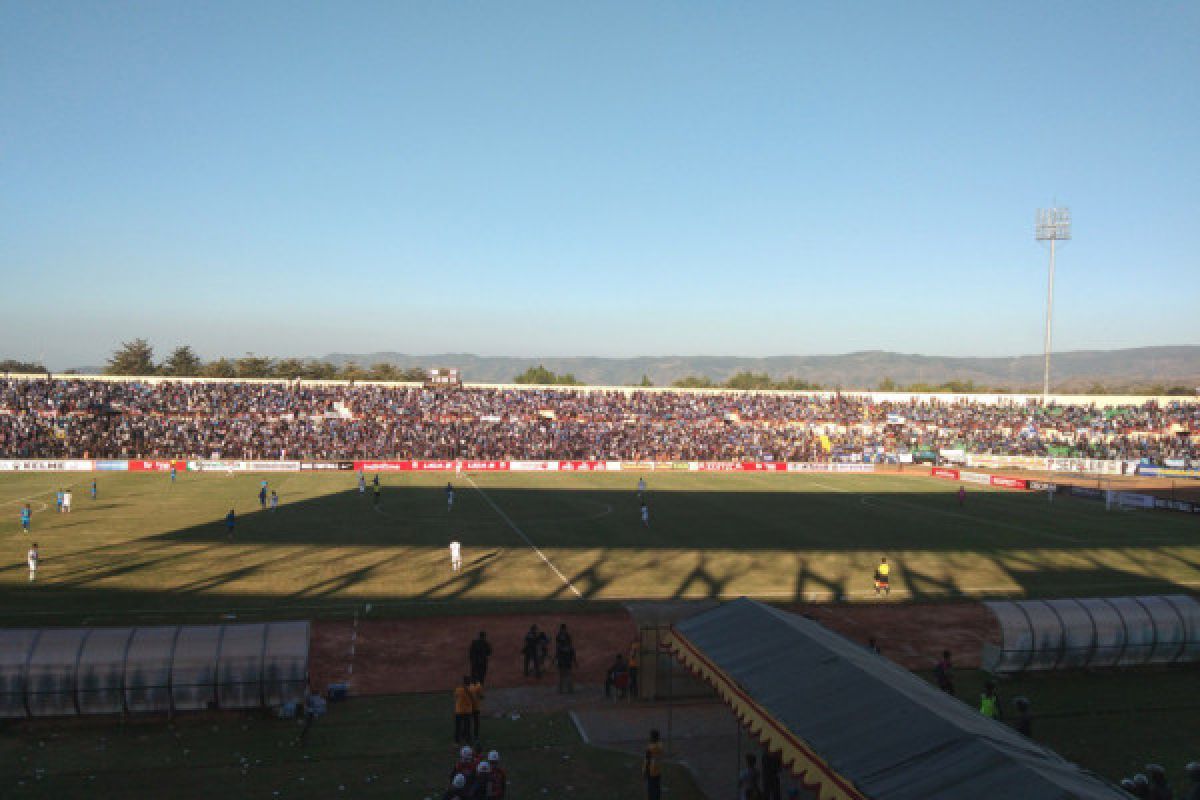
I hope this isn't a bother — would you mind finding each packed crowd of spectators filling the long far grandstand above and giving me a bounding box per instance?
[0,378,1200,464]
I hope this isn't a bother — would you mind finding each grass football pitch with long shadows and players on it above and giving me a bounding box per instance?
[0,473,1200,625]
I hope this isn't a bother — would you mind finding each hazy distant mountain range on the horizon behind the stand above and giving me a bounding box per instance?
[319,345,1200,392]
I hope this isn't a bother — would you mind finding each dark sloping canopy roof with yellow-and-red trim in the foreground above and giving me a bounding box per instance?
[671,599,1128,800]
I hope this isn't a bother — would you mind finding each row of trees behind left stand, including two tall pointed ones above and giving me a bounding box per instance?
[104,338,428,381]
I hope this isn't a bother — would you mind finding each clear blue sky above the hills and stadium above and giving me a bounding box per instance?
[0,0,1200,368]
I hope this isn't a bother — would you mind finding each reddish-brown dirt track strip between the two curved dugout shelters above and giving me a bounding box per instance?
[310,602,1000,694]
